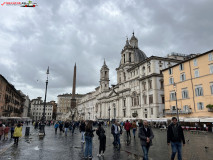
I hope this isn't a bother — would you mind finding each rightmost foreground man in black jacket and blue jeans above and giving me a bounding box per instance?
[167,117,185,160]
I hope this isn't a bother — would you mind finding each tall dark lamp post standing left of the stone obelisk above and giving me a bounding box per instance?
[39,66,49,136]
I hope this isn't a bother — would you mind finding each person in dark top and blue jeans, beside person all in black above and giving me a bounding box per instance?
[84,121,95,159]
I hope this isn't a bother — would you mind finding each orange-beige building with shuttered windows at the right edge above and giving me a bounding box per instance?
[162,50,213,119]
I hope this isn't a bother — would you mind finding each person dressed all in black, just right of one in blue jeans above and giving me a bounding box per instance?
[96,123,106,157]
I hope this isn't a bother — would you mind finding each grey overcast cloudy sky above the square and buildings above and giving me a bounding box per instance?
[0,0,213,100]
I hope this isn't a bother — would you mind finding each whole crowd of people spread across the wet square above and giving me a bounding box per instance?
[0,117,185,160]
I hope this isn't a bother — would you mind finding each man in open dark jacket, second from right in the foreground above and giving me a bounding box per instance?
[138,120,154,160]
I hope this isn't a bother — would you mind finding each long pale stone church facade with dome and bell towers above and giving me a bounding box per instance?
[76,33,181,121]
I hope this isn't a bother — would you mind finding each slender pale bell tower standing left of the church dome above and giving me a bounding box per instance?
[100,59,109,92]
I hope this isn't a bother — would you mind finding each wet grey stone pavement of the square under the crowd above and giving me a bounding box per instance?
[0,126,213,160]
